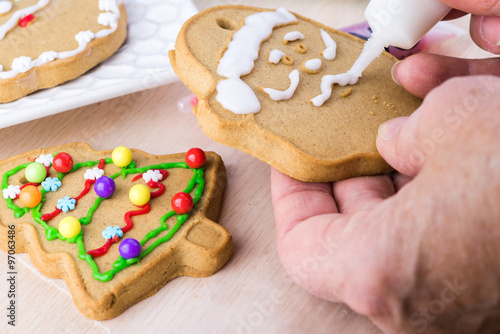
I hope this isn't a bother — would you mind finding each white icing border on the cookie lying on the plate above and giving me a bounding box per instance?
[0,0,123,79]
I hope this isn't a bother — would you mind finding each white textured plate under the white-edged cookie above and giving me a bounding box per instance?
[0,0,197,128]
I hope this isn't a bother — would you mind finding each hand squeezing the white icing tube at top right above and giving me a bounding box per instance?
[392,0,500,98]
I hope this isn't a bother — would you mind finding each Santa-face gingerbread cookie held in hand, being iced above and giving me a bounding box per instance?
[169,6,421,182]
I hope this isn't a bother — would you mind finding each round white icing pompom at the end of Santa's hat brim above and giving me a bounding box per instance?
[215,78,260,114]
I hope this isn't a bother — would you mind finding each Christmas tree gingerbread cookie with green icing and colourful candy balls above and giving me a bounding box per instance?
[0,143,233,320]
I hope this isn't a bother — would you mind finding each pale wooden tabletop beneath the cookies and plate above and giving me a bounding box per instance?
[0,0,487,334]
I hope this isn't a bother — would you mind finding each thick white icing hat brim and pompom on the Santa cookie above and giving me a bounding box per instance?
[216,8,297,114]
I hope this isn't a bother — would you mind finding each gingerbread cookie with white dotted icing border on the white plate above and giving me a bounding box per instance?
[0,0,127,102]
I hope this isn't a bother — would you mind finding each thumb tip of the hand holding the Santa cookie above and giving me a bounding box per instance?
[377,109,425,177]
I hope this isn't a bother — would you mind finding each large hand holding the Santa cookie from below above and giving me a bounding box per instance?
[271,76,500,334]
